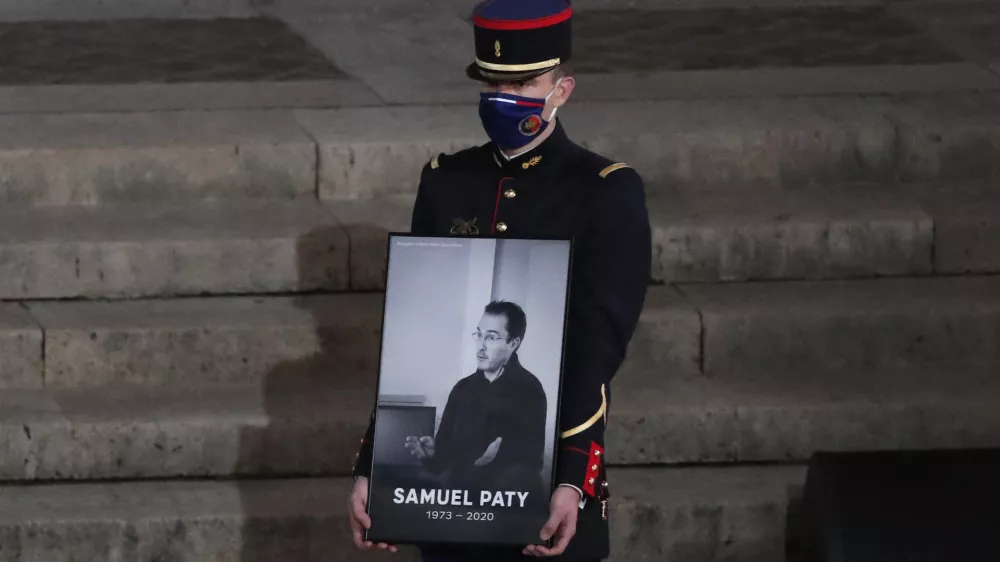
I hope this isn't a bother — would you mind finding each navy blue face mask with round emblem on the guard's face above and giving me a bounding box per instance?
[479,79,561,150]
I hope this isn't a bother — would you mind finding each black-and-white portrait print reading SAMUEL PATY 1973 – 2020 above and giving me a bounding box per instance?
[368,235,571,545]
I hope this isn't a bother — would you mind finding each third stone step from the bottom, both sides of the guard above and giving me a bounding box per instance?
[0,276,1000,389]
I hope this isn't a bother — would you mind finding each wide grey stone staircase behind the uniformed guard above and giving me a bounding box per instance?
[0,0,1000,562]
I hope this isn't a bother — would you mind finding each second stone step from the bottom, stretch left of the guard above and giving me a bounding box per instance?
[0,383,374,481]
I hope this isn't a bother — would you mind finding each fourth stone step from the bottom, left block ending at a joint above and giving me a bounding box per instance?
[0,201,350,299]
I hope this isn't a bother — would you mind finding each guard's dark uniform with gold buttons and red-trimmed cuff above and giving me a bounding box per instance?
[355,0,652,561]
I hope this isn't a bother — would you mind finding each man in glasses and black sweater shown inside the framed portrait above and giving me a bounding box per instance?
[406,301,548,502]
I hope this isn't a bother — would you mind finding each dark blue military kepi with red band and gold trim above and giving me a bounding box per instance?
[466,0,573,82]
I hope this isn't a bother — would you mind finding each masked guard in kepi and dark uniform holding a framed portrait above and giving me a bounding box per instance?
[349,0,652,562]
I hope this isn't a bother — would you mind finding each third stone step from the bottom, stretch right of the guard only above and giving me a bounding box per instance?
[625,276,1000,381]
